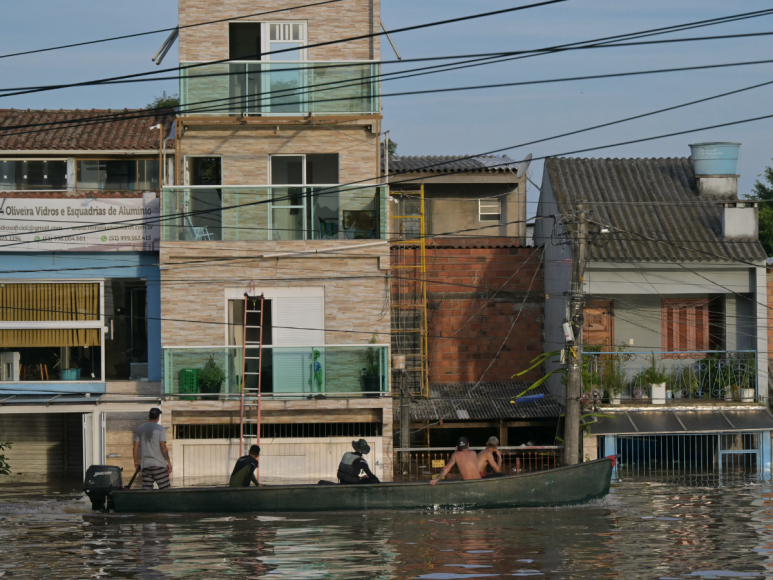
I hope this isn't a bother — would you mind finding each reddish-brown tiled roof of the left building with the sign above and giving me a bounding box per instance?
[0,109,175,151]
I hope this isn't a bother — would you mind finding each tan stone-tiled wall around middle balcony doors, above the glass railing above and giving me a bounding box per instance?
[179,125,379,185]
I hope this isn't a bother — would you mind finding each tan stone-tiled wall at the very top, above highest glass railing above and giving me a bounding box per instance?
[179,0,381,62]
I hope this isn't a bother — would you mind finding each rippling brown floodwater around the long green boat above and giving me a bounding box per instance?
[0,482,773,580]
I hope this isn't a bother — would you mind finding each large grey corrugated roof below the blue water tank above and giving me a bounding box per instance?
[545,157,766,262]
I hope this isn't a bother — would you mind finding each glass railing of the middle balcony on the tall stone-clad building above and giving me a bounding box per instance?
[162,185,387,241]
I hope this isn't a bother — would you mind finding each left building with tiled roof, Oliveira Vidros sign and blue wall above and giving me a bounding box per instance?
[0,110,173,479]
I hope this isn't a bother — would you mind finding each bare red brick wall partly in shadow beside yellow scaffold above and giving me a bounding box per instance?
[392,238,544,383]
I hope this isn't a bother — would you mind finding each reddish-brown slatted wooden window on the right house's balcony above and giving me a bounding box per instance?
[661,298,710,358]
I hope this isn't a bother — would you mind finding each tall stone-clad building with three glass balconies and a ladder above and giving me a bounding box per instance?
[160,0,392,485]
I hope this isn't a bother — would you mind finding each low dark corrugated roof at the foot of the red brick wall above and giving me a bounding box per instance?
[395,381,563,421]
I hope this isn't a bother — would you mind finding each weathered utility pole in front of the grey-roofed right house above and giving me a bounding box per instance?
[564,202,588,465]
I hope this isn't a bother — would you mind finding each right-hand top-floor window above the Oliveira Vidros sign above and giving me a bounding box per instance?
[76,159,158,191]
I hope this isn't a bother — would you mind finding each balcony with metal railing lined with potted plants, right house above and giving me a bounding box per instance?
[582,349,765,404]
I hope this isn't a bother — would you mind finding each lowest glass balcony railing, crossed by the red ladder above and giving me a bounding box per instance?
[164,344,389,400]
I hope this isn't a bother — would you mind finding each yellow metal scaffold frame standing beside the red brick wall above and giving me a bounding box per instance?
[390,184,429,398]
